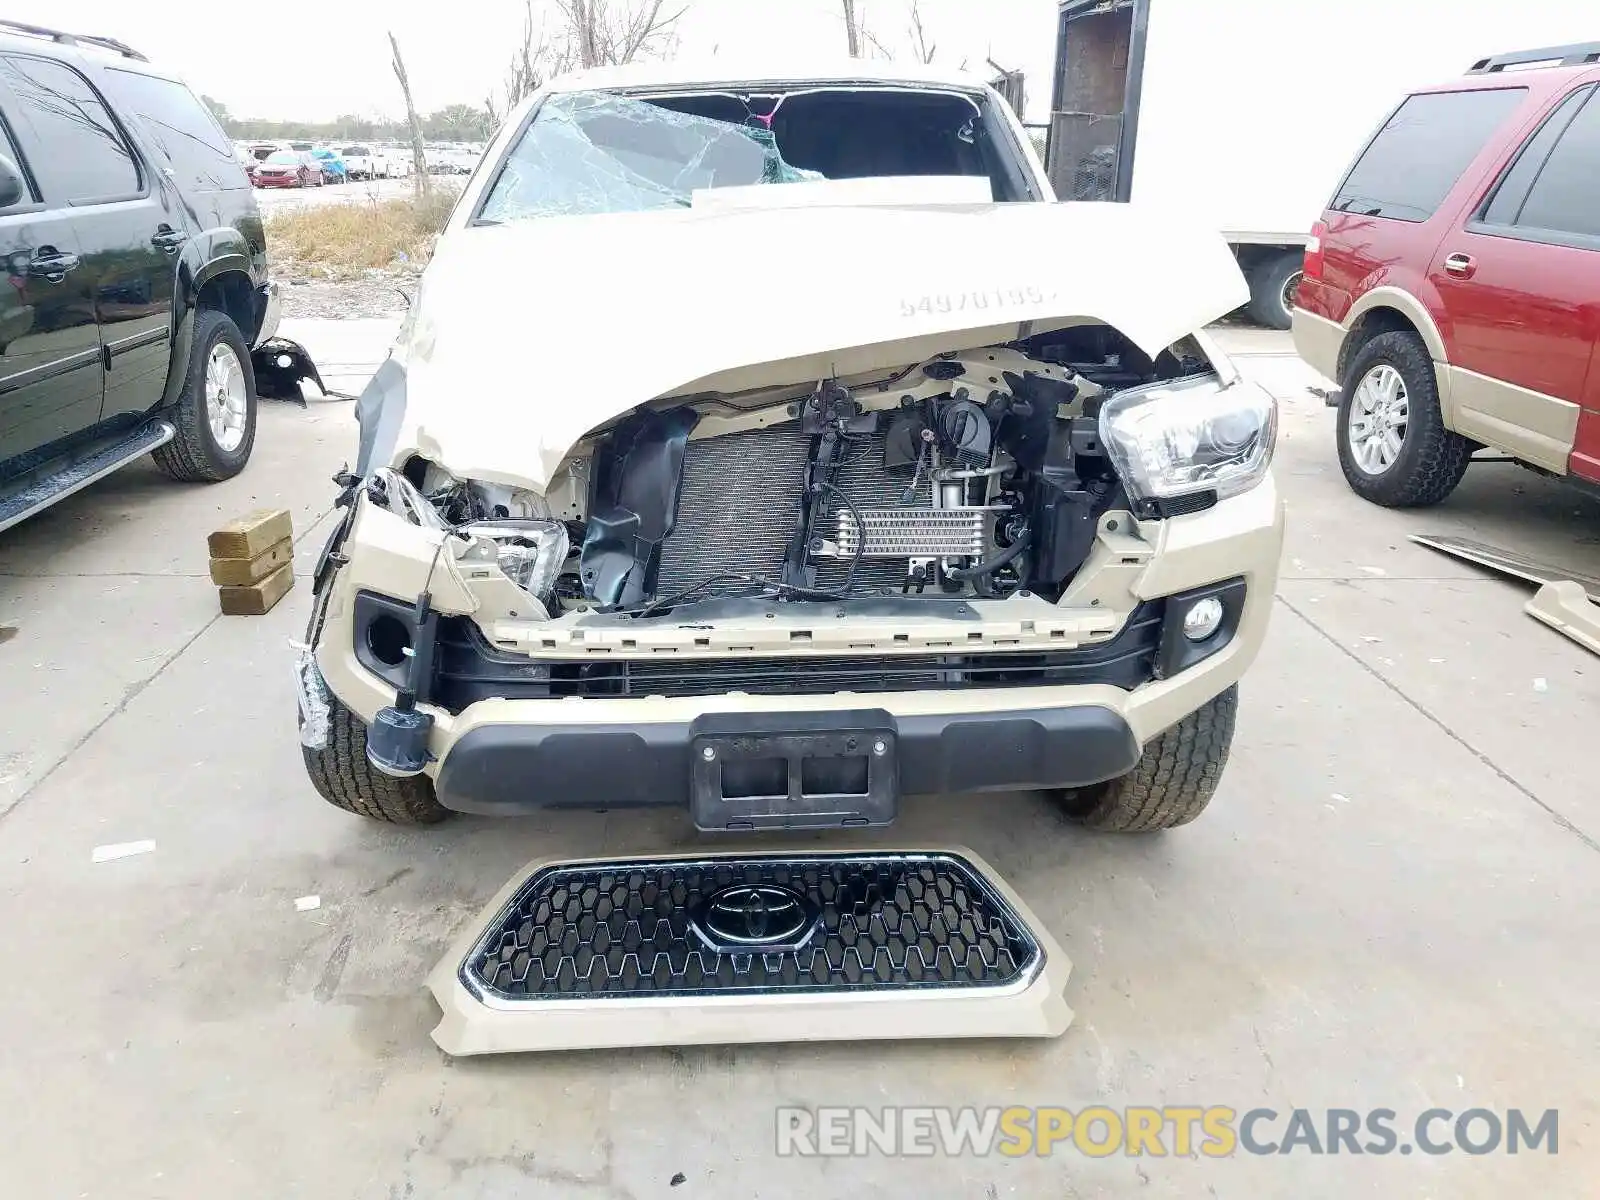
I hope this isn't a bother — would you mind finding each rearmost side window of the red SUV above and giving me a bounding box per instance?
[1330,88,1526,221]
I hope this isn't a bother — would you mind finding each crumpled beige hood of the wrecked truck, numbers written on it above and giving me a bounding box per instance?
[390,203,1248,491]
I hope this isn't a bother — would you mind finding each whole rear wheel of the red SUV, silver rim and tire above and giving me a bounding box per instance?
[1338,331,1474,509]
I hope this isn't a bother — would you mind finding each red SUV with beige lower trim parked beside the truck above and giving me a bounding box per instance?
[1294,43,1600,507]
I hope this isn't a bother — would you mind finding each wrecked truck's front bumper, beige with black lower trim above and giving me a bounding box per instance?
[317,475,1283,813]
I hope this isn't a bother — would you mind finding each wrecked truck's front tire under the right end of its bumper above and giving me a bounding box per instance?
[1061,685,1238,834]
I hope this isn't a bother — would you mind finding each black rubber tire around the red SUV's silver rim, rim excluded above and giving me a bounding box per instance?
[1338,330,1474,509]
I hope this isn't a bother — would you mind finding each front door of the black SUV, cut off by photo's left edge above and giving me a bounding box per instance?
[0,101,106,478]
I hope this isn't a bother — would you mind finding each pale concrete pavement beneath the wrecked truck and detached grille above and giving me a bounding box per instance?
[0,322,1600,1200]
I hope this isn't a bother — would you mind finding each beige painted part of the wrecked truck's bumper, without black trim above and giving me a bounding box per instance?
[317,474,1283,774]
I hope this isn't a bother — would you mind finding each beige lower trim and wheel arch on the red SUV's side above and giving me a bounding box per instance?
[1294,288,1579,475]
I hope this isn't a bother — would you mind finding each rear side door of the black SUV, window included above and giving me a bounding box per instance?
[0,53,176,435]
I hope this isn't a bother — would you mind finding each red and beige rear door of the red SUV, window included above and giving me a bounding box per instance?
[1429,85,1600,477]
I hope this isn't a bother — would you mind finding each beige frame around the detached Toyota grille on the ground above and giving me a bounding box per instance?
[427,845,1072,1056]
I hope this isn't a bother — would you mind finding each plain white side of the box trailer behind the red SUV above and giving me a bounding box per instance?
[1133,0,1600,240]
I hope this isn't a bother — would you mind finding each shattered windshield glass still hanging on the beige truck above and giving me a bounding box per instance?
[480,91,822,222]
